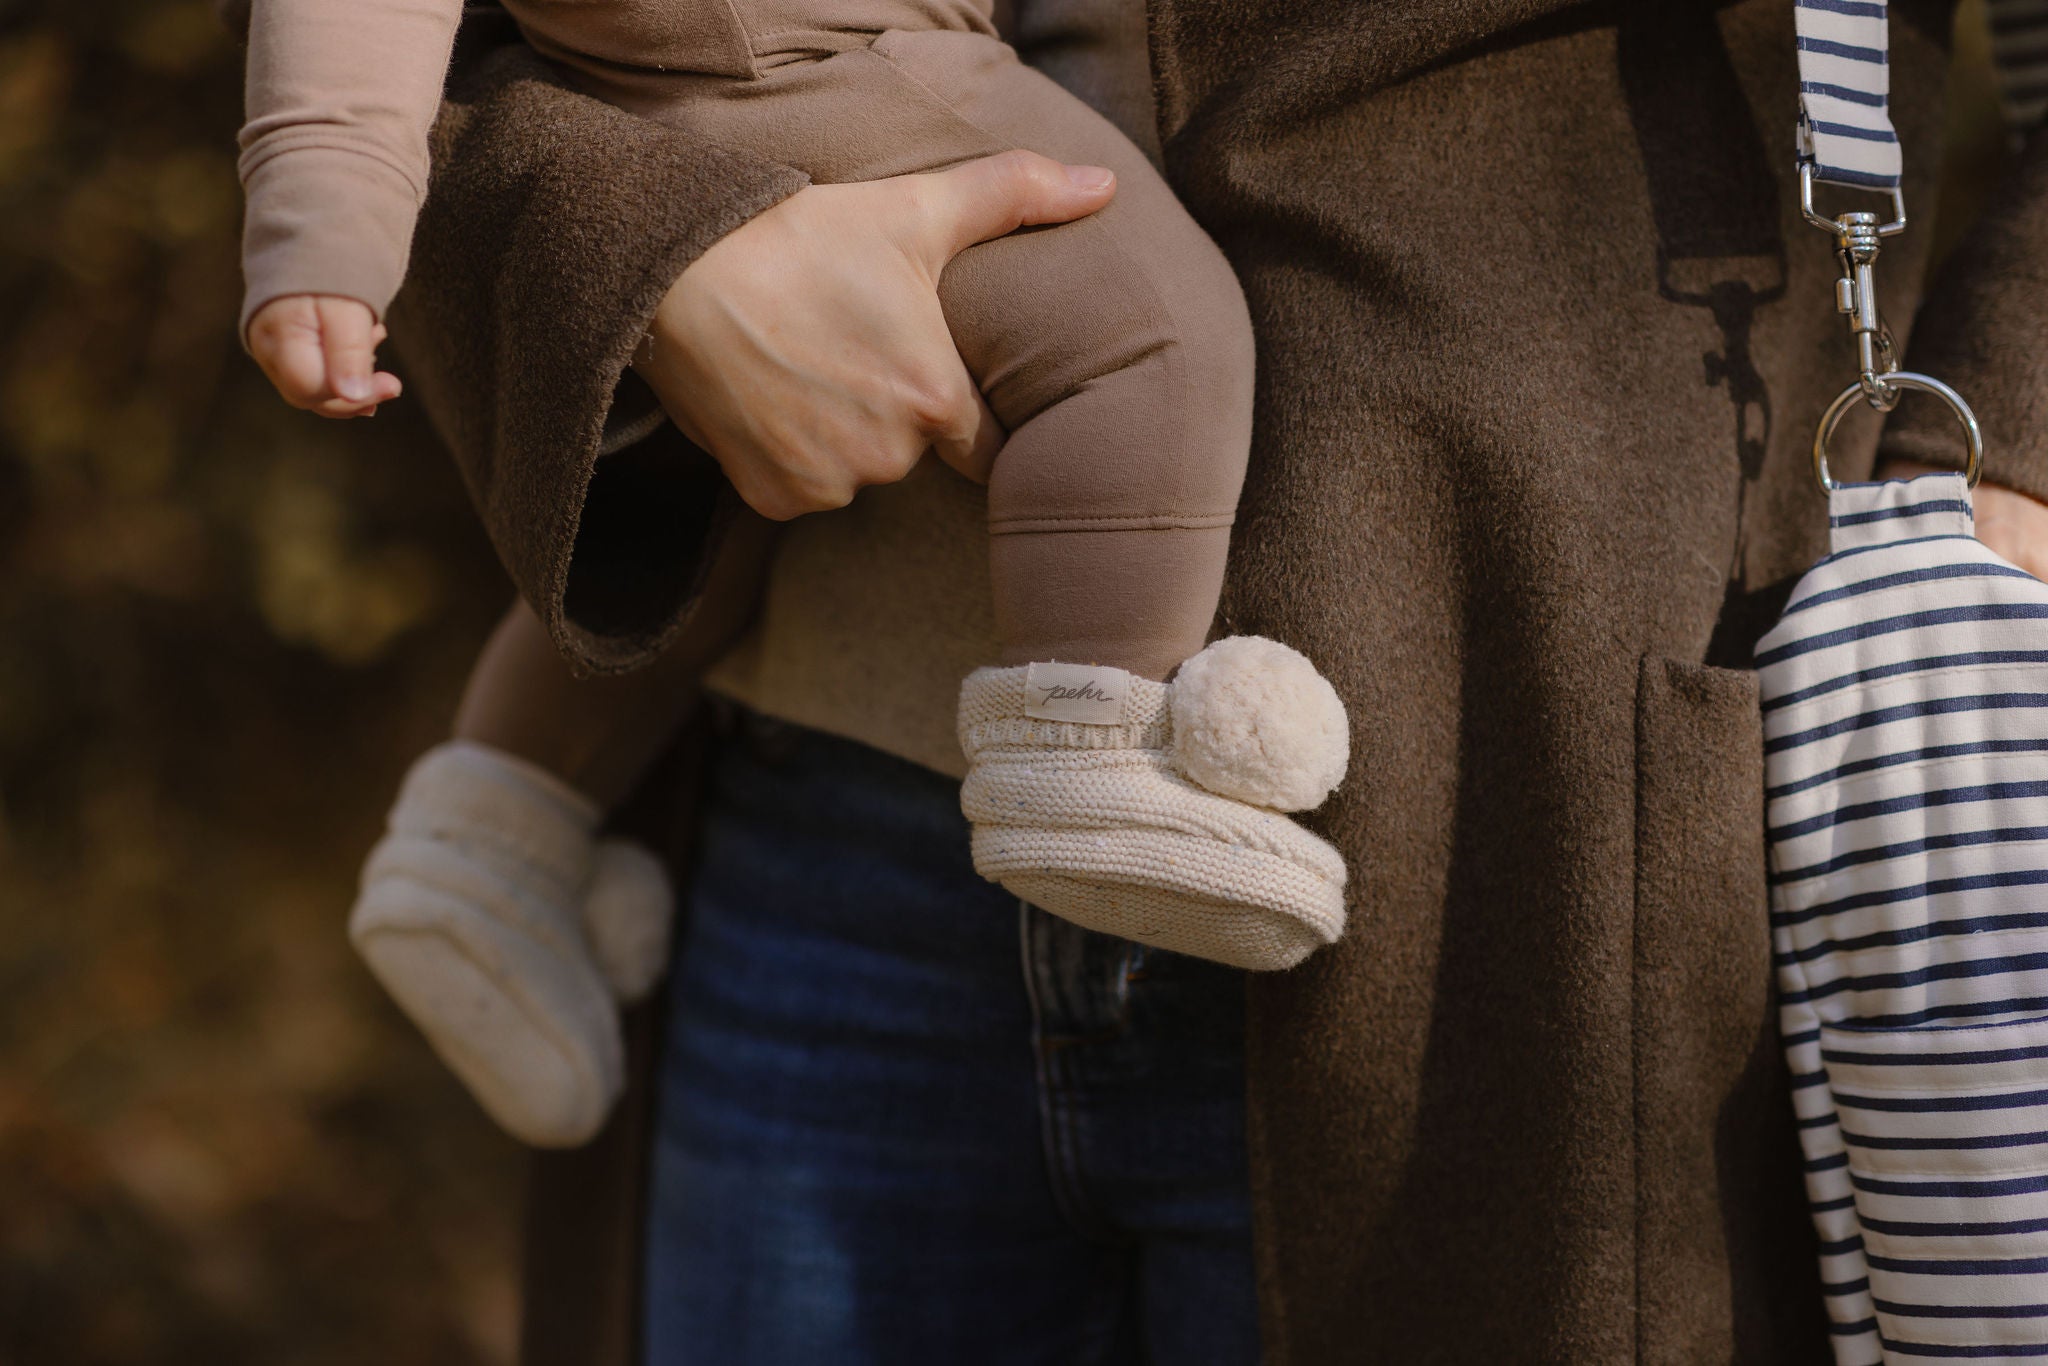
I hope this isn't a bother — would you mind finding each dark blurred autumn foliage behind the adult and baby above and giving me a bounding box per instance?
[0,0,2001,1366]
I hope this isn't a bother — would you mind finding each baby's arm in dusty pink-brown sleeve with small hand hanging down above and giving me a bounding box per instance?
[242,0,461,418]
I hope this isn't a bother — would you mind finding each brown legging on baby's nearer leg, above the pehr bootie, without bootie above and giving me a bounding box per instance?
[877,35,1253,680]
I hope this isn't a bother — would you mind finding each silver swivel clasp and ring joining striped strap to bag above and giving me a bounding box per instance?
[1798,164,1985,492]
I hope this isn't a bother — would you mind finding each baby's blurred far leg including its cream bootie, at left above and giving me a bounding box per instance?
[348,501,772,1147]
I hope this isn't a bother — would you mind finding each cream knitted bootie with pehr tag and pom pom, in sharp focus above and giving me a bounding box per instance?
[961,635,1350,969]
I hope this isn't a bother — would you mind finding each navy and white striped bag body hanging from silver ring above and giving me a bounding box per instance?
[1757,475,2048,1366]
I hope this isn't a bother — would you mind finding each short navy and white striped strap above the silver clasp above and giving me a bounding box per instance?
[1792,0,1901,190]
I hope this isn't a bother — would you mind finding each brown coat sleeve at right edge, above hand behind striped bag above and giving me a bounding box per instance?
[1882,133,2048,502]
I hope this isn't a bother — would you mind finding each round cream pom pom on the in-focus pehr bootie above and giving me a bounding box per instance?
[1171,635,1352,811]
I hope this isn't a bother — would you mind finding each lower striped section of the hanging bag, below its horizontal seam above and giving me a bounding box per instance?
[1821,1018,2048,1360]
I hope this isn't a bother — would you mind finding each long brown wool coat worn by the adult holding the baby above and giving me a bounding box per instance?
[376,0,2048,1366]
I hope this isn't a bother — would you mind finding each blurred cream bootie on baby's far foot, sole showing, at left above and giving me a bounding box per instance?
[348,739,674,1147]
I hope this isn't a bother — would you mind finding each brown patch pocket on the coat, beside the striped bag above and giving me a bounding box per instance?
[1632,655,1827,1362]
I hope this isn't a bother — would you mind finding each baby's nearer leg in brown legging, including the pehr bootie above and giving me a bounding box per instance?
[622,31,1348,969]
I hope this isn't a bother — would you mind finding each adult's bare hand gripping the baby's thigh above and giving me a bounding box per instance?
[633,152,1116,520]
